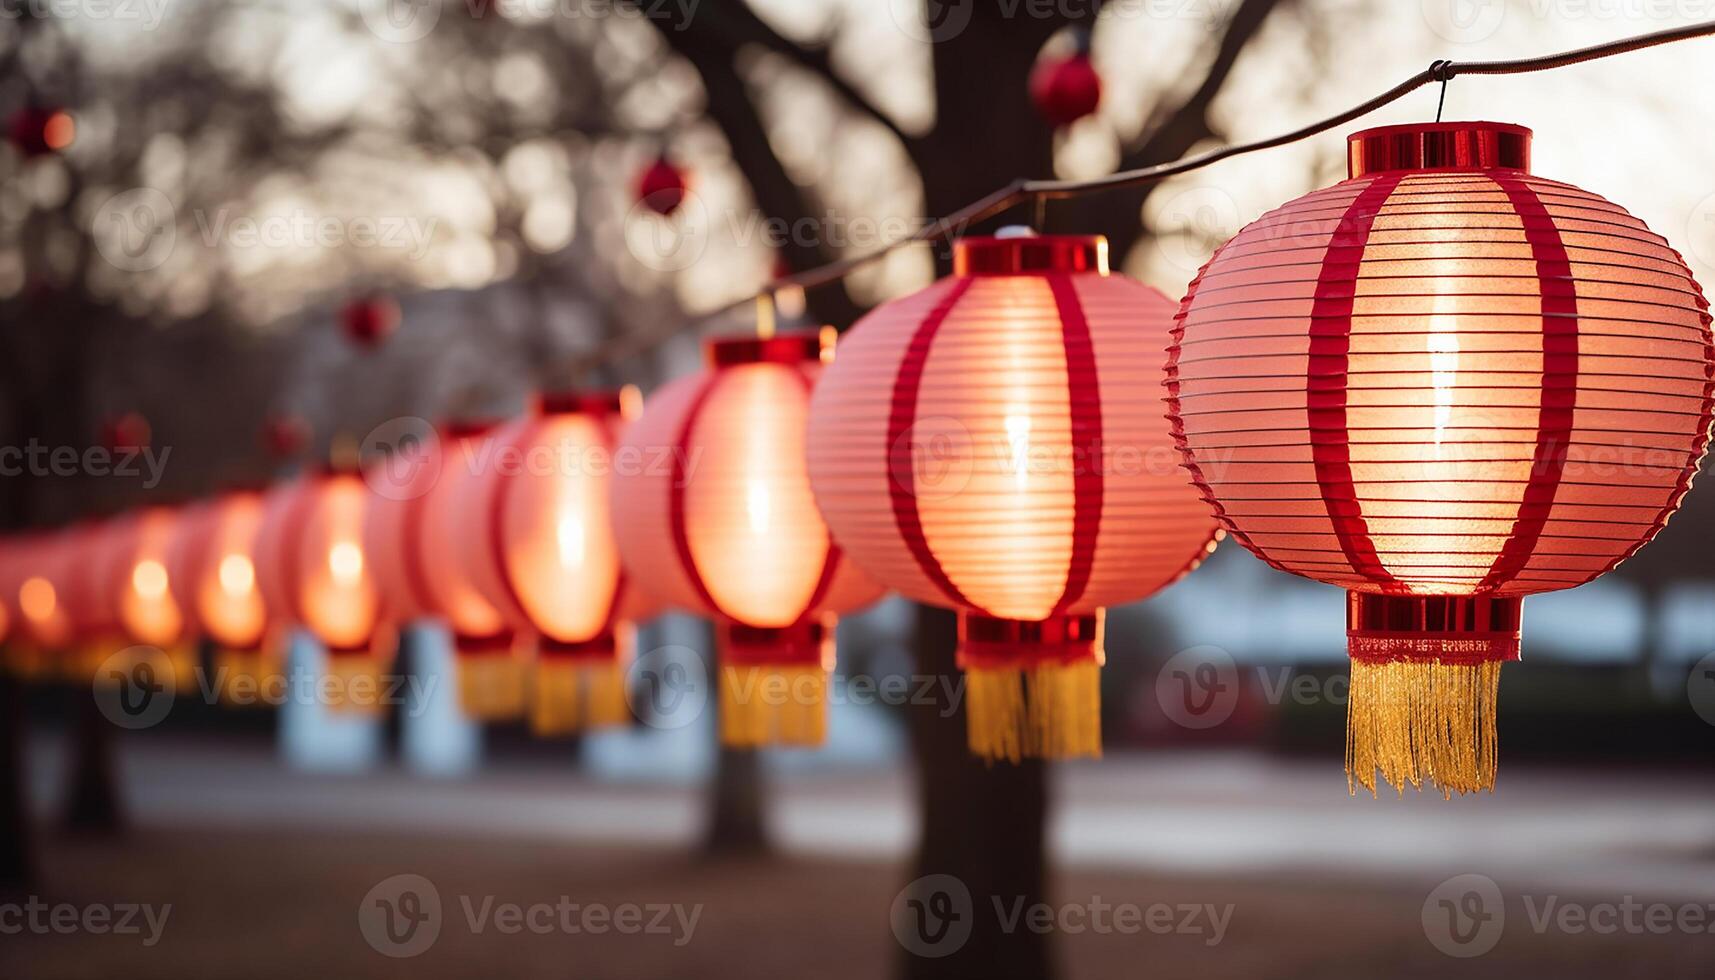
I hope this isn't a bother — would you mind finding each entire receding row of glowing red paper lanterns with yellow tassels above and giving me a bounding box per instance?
[0,124,1715,793]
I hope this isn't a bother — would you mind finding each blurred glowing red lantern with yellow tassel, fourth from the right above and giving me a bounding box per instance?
[460,391,648,735]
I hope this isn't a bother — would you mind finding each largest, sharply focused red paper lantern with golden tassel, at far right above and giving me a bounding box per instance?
[1168,122,1715,793]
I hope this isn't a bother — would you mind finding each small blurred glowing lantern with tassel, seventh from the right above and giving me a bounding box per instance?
[168,491,278,702]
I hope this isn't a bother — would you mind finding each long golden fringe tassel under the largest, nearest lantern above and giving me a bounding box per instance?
[1346,661,1501,798]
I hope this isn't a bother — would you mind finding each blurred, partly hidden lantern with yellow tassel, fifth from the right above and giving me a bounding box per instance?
[417,420,525,721]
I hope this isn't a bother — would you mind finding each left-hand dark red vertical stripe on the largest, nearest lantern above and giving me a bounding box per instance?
[1305,173,1399,589]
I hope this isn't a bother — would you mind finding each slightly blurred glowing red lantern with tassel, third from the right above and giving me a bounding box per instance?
[614,331,882,745]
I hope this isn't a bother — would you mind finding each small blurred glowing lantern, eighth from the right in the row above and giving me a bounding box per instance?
[89,506,197,688]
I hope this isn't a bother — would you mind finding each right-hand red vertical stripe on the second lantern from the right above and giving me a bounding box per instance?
[1048,273,1103,616]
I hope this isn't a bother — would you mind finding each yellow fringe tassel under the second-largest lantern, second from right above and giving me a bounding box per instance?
[966,661,1101,762]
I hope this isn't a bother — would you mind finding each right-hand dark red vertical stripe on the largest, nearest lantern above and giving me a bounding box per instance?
[1477,177,1578,592]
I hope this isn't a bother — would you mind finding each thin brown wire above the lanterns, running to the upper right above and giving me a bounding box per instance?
[576,21,1715,374]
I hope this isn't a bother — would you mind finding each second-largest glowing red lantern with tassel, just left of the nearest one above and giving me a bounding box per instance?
[809,235,1216,760]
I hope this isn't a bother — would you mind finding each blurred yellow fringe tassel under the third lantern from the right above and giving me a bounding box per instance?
[720,664,828,748]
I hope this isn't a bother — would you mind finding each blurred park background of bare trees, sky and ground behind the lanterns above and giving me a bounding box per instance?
[0,0,1715,978]
